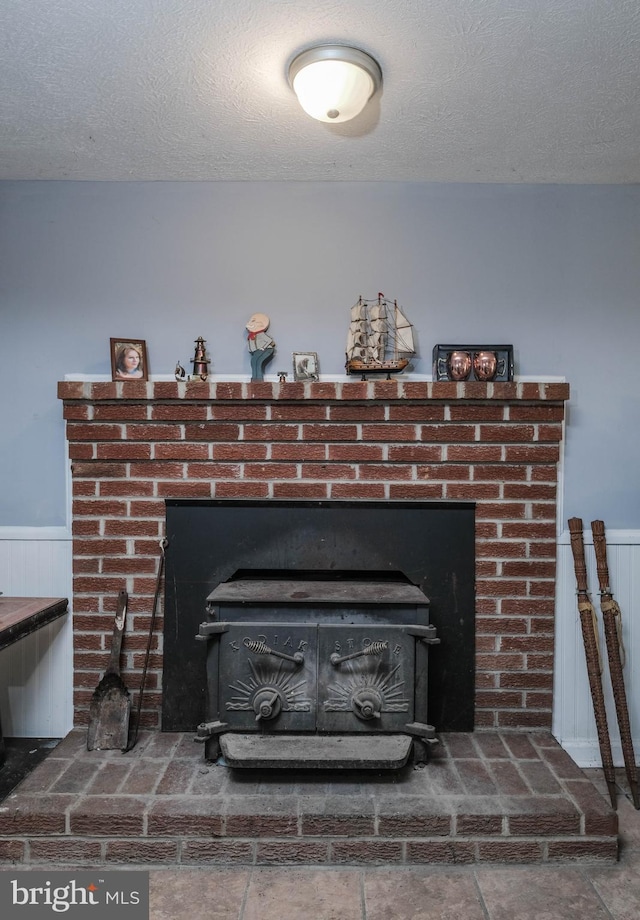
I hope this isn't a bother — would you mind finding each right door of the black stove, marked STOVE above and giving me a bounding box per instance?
[317,624,416,732]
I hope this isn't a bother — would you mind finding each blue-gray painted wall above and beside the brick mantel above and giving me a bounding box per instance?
[0,182,640,528]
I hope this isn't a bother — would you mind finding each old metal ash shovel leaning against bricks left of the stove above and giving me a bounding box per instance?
[87,591,131,751]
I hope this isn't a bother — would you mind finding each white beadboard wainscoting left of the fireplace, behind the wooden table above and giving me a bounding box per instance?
[0,527,73,738]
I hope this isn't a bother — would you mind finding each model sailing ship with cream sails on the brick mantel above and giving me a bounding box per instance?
[346,294,416,380]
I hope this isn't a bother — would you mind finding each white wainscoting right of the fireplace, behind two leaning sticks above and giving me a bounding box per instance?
[553,522,640,767]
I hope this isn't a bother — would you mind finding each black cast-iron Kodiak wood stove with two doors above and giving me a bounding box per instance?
[197,573,440,769]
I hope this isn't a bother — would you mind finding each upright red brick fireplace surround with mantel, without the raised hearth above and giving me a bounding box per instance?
[58,379,569,728]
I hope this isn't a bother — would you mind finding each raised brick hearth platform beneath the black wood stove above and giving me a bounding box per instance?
[0,730,618,868]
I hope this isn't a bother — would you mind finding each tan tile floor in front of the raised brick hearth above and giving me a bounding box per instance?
[150,771,640,920]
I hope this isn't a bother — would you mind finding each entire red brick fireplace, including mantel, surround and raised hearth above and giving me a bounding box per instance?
[0,379,618,867]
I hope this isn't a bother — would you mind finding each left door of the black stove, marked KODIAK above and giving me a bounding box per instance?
[218,622,317,732]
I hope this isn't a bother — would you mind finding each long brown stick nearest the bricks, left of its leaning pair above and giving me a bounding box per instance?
[569,518,617,810]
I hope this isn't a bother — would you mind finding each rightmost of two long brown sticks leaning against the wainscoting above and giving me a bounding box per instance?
[591,521,640,809]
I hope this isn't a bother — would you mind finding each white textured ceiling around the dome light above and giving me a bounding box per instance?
[0,0,640,183]
